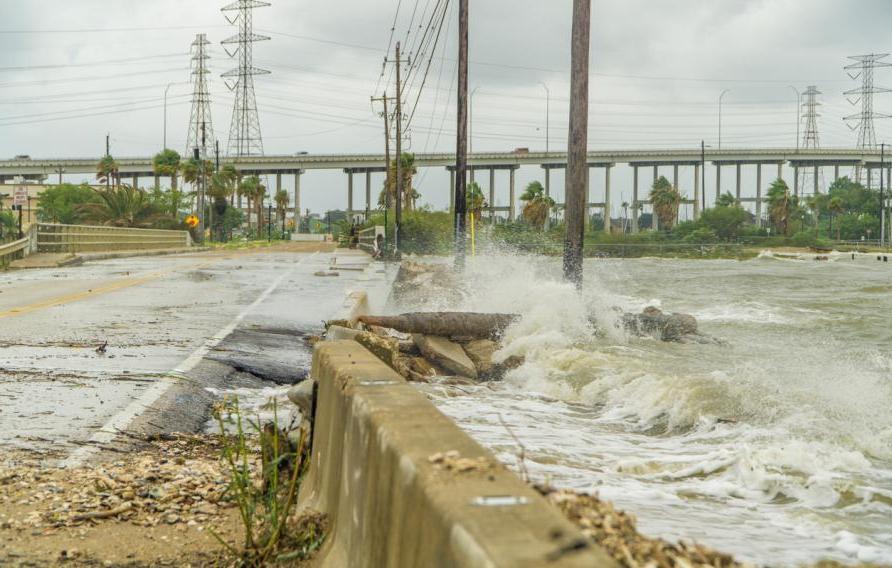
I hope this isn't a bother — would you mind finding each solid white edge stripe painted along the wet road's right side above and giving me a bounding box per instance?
[59,252,319,468]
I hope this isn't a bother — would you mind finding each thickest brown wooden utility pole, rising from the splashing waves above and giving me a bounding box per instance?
[564,0,591,289]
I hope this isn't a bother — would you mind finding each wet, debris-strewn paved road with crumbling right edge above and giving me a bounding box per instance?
[0,245,376,462]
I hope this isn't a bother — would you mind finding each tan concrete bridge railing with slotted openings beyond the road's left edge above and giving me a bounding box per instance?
[37,223,192,253]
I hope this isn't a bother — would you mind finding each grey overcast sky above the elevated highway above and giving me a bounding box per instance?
[0,0,892,214]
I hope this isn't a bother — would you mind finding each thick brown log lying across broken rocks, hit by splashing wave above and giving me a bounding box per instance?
[359,312,520,339]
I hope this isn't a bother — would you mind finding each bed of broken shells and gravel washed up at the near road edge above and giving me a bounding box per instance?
[0,434,234,531]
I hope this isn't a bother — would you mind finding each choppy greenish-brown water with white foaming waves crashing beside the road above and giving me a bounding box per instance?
[418,256,892,565]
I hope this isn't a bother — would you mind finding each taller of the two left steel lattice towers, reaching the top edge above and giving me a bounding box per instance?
[222,0,270,156]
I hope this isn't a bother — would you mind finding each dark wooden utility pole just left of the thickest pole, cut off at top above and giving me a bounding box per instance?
[453,0,468,268]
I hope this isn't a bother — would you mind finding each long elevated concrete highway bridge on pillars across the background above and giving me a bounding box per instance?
[0,148,892,231]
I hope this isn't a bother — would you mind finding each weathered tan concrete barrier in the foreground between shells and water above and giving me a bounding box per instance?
[301,341,615,568]
